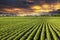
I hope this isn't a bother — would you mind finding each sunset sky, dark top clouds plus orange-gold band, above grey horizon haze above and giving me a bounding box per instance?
[0,0,60,14]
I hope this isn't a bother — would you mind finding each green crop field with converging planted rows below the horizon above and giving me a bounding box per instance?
[0,17,60,40]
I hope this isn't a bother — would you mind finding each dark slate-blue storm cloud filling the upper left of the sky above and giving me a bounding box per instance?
[0,0,32,8]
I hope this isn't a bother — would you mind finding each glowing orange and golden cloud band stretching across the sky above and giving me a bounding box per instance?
[0,3,60,14]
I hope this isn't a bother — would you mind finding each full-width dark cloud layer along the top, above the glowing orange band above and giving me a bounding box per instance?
[0,0,60,8]
